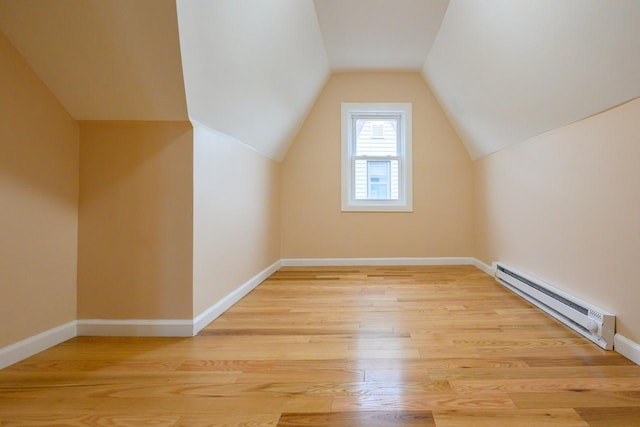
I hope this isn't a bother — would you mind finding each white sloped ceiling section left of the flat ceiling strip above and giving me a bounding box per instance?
[178,0,330,159]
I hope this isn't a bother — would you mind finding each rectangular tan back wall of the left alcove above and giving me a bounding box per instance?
[78,122,193,319]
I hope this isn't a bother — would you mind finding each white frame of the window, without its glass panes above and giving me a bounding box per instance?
[342,102,413,212]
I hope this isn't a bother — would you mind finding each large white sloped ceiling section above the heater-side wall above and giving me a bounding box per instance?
[423,0,640,158]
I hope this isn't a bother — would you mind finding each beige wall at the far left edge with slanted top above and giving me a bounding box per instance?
[0,33,78,347]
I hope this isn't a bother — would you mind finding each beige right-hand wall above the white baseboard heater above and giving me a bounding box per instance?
[474,100,640,342]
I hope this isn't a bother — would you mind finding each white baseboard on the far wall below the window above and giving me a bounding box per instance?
[281,257,475,267]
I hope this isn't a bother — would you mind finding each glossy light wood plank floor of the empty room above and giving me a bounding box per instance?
[0,266,640,427]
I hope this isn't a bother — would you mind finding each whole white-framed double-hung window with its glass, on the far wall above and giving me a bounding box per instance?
[342,103,412,212]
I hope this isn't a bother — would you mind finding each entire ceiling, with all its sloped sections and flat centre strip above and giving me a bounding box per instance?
[0,0,640,159]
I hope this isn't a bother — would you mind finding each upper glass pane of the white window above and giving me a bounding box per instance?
[355,118,398,156]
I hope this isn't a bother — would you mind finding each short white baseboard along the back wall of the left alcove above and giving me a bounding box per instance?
[78,319,193,337]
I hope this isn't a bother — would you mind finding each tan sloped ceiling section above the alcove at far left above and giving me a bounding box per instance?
[0,0,188,120]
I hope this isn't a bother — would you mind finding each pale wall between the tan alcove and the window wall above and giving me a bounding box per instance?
[193,127,280,317]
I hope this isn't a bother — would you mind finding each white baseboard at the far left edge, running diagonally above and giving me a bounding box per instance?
[0,320,76,369]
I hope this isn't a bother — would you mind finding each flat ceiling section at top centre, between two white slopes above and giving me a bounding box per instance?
[314,0,449,71]
